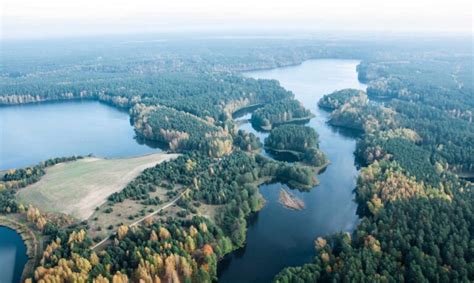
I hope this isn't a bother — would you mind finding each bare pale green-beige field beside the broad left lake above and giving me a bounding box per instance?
[17,153,178,220]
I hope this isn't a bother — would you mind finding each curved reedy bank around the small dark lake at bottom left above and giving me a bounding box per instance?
[0,216,42,282]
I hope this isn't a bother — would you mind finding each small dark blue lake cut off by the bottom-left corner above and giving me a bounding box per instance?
[0,226,28,283]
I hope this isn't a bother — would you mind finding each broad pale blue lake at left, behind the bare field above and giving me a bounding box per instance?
[0,100,159,170]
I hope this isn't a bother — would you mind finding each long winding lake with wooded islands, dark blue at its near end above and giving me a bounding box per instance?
[218,60,366,282]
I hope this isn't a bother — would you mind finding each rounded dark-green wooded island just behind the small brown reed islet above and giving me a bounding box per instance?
[265,125,328,167]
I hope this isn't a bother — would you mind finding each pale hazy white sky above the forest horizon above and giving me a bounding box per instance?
[1,0,474,39]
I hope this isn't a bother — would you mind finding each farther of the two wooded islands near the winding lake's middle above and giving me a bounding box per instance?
[251,99,314,131]
